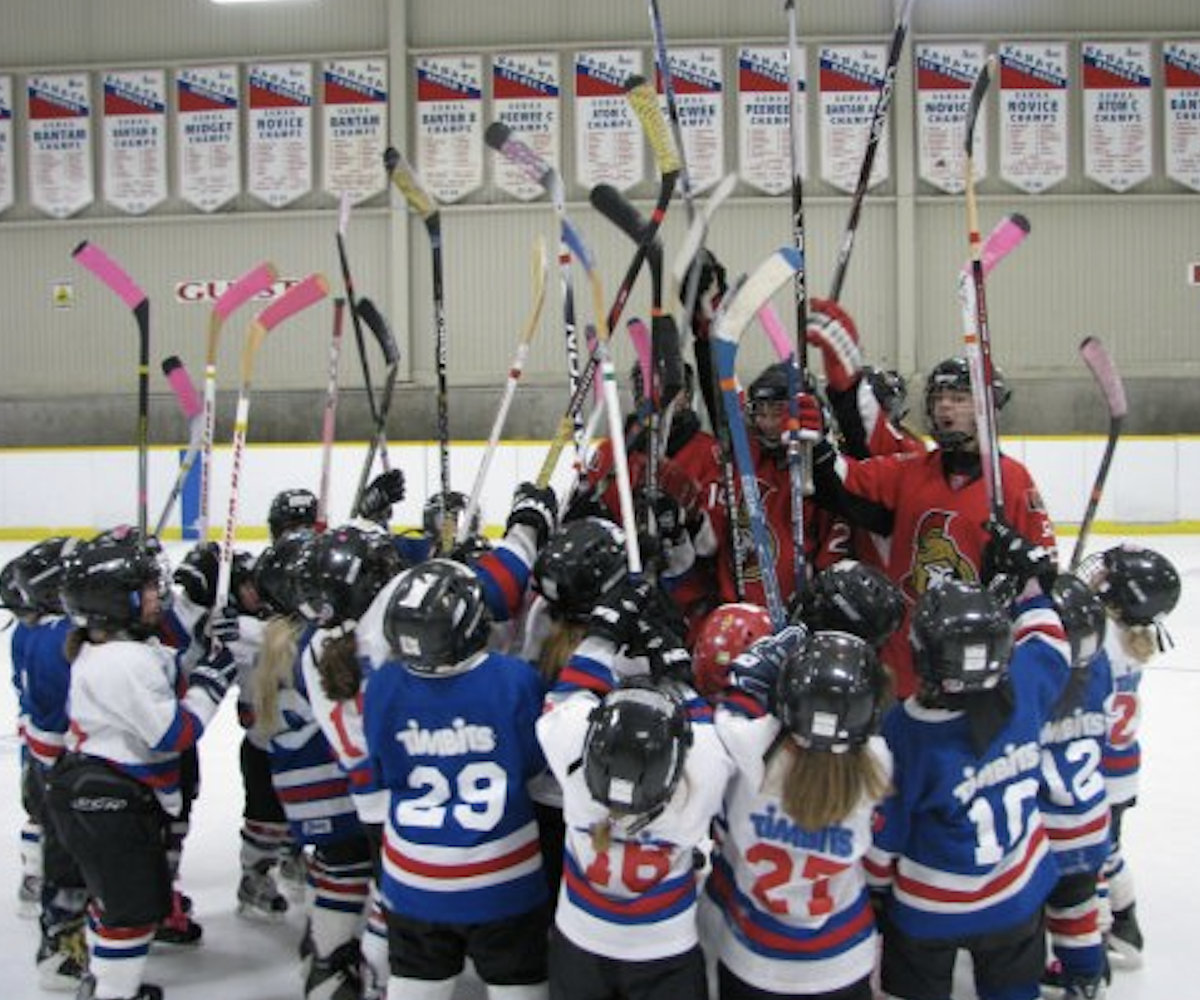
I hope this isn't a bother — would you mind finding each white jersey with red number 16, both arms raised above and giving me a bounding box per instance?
[538,689,733,962]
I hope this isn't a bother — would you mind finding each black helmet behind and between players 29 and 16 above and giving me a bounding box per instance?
[533,517,629,622]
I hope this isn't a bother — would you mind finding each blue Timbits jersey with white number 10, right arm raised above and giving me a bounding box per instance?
[866,598,1069,940]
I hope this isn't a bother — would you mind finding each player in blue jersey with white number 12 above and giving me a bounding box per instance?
[1038,573,1112,1000]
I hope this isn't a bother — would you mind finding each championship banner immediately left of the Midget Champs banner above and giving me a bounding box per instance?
[103,70,167,215]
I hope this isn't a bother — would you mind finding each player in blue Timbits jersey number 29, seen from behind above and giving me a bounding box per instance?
[360,557,552,1000]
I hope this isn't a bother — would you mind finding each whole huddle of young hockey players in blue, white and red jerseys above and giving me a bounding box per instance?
[0,283,1180,1000]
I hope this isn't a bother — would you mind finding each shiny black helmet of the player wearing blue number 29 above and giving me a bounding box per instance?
[383,559,492,675]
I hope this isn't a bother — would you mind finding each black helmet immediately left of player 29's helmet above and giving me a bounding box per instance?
[295,525,401,628]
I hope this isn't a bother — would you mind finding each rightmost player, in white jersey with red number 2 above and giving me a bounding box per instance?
[1079,543,1180,969]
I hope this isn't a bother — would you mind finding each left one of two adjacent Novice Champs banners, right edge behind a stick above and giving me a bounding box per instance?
[917,44,988,194]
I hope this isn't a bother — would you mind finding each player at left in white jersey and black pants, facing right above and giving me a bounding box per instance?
[47,537,236,1000]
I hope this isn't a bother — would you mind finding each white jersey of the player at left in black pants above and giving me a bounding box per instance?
[67,639,225,816]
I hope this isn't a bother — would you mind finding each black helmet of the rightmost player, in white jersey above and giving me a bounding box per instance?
[1079,543,1181,627]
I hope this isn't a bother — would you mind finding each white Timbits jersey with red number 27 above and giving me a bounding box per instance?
[706,708,892,994]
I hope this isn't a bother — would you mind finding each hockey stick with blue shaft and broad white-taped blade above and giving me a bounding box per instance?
[713,247,804,629]
